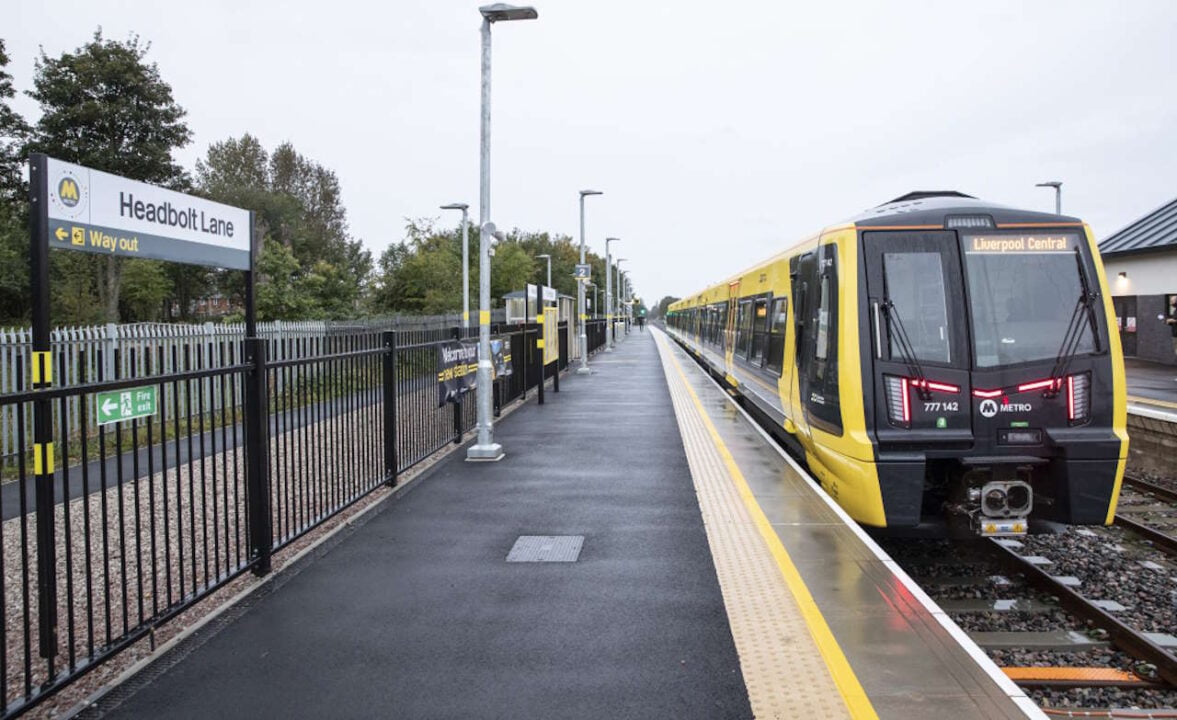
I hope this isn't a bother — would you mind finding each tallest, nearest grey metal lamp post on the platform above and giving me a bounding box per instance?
[466,2,539,461]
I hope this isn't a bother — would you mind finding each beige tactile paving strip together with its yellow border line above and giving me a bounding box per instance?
[654,334,878,719]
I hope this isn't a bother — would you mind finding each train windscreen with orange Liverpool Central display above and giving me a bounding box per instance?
[962,233,1095,368]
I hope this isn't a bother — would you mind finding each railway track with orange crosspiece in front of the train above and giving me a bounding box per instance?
[889,533,1177,718]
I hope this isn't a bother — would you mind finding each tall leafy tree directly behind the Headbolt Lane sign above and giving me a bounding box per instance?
[28,29,192,322]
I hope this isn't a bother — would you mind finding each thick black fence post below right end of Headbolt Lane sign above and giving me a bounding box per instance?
[245,338,273,575]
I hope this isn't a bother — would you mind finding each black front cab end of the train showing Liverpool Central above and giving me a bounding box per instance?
[858,222,1128,535]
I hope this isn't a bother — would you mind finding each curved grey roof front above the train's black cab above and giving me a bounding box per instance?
[847,191,1082,227]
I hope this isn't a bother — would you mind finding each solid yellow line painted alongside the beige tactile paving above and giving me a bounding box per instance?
[667,341,878,719]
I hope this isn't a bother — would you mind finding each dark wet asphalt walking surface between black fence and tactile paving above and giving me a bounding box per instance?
[96,333,751,720]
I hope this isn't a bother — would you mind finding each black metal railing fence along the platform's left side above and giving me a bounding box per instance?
[0,321,605,716]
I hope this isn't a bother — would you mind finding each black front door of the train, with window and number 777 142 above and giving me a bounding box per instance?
[863,231,972,442]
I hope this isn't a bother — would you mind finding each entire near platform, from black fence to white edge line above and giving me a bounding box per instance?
[82,332,1042,720]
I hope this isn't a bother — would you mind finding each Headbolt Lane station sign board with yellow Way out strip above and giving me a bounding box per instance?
[46,158,251,269]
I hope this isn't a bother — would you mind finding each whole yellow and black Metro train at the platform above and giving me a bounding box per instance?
[666,192,1128,535]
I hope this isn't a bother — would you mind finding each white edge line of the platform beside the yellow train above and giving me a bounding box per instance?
[651,326,1050,720]
